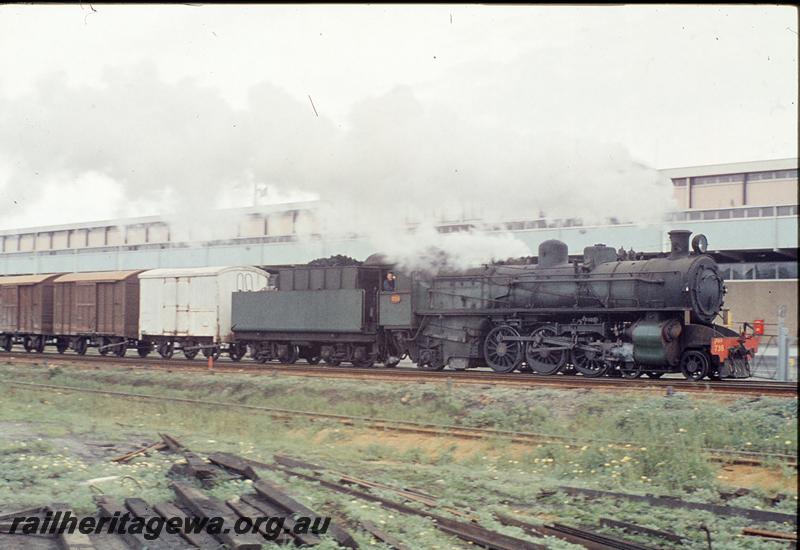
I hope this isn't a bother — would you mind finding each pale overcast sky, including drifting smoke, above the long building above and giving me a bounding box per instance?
[0,4,798,242]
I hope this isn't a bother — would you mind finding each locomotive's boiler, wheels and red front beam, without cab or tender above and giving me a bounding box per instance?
[394,230,758,380]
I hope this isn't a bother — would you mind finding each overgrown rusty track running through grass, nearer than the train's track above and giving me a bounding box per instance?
[4,381,797,468]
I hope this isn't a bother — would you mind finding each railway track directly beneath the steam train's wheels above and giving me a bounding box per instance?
[0,352,798,398]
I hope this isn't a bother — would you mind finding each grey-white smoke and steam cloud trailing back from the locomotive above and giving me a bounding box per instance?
[0,64,672,267]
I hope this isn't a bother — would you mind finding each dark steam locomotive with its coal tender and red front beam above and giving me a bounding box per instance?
[232,230,759,380]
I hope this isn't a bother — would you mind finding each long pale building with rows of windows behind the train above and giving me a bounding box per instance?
[0,158,798,335]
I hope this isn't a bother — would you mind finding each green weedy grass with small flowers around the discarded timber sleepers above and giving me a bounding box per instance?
[0,366,797,549]
